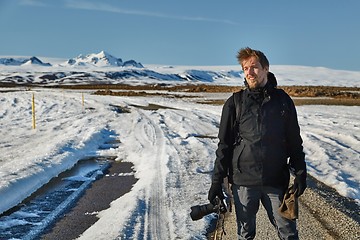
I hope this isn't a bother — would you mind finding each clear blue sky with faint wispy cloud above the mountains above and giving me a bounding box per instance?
[0,0,360,71]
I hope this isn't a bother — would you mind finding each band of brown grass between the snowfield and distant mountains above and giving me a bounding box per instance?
[88,85,360,106]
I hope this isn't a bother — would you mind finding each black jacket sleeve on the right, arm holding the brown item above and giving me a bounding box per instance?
[286,94,306,175]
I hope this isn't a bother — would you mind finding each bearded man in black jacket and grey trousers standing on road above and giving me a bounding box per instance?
[208,47,306,239]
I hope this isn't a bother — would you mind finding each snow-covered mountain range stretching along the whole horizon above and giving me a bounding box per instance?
[0,51,360,87]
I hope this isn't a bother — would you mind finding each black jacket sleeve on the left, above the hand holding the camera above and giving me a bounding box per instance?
[212,96,236,184]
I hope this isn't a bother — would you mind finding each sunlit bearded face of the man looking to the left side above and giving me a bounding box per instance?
[241,56,269,89]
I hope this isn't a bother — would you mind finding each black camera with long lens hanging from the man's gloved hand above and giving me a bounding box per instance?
[190,198,227,221]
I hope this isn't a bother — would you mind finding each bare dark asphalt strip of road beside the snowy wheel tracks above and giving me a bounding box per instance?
[41,162,137,240]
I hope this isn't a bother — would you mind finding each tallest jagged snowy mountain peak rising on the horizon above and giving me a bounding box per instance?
[62,51,144,68]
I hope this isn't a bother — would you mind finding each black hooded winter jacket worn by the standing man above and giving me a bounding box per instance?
[212,74,306,188]
